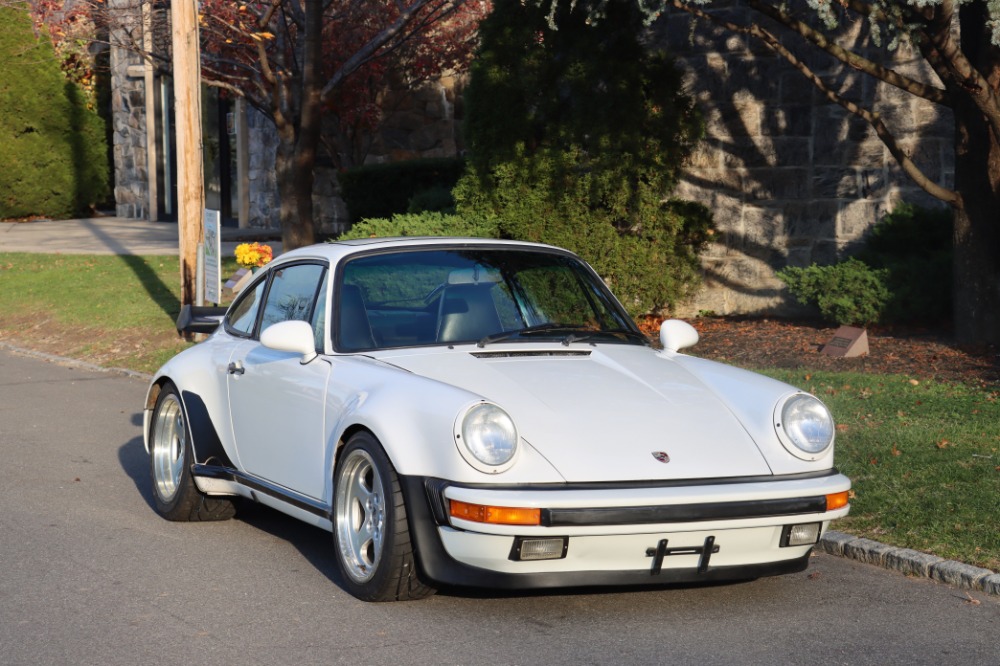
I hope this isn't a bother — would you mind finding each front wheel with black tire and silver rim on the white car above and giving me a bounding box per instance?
[333,432,435,601]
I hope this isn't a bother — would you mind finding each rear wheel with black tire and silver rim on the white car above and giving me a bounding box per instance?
[149,382,236,521]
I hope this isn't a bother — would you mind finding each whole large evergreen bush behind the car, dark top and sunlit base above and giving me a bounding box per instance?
[454,0,712,314]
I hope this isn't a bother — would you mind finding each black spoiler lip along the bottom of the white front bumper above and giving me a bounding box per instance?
[399,476,809,590]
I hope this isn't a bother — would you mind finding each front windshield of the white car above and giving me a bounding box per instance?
[334,247,647,351]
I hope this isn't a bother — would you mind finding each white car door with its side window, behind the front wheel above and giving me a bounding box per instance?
[227,263,331,499]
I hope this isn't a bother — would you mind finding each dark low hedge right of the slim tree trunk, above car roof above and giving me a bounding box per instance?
[338,158,465,221]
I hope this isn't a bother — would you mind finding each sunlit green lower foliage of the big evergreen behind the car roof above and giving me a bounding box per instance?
[455,151,712,315]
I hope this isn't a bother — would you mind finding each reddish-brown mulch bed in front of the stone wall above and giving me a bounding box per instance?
[656,317,1000,386]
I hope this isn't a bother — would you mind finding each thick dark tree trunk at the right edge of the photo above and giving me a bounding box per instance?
[953,5,1000,344]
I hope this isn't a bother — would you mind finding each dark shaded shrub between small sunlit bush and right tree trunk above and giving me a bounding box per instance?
[857,204,953,323]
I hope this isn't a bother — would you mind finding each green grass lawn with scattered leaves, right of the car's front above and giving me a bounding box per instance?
[767,370,1000,571]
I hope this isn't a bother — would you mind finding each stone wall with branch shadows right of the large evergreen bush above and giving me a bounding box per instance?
[661,9,954,316]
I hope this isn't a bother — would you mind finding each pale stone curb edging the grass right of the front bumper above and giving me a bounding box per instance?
[819,530,1000,596]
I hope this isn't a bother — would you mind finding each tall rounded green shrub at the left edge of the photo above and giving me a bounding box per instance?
[0,6,110,218]
